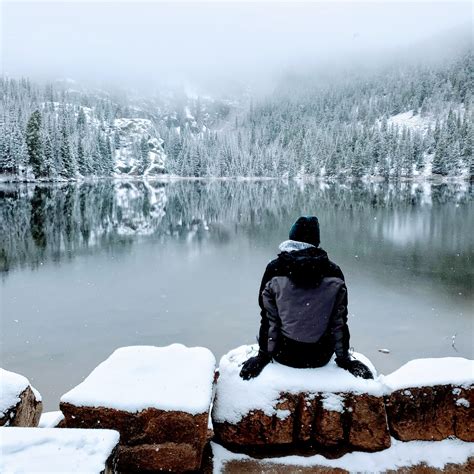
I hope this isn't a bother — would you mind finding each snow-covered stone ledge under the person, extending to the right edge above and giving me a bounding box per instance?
[212,345,474,452]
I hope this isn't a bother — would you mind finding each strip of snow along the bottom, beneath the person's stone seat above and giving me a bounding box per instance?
[211,438,474,474]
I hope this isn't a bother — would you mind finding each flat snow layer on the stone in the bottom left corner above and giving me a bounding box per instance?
[0,427,119,474]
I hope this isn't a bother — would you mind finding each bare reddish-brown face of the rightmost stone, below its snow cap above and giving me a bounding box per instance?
[386,385,474,441]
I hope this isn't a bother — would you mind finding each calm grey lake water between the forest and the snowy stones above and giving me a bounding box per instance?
[0,181,474,410]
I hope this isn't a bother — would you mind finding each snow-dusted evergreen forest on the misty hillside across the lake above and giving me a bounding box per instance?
[0,51,474,180]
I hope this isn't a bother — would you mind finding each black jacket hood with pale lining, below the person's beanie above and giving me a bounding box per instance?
[278,240,329,287]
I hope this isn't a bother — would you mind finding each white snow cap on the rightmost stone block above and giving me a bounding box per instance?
[383,357,474,391]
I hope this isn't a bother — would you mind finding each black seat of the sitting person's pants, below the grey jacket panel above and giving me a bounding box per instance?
[273,333,334,369]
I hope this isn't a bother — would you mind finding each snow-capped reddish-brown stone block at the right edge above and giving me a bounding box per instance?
[384,357,474,441]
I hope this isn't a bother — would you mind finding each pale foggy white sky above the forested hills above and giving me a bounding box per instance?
[1,0,472,90]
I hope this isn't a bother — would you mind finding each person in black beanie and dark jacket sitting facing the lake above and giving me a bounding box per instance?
[240,216,373,380]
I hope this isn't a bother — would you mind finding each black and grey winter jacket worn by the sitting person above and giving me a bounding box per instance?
[259,240,349,366]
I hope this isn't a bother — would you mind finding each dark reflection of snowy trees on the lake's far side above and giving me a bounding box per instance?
[0,181,474,294]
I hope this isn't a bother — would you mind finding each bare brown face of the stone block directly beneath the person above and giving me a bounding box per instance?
[213,393,390,451]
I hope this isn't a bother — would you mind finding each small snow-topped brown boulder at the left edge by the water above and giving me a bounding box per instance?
[0,369,43,426]
